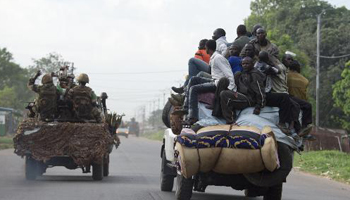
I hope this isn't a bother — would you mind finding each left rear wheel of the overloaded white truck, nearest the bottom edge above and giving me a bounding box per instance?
[175,174,193,200]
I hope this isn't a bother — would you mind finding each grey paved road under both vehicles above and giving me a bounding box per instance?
[0,137,350,200]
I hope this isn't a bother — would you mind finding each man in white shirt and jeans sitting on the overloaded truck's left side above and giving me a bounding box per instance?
[173,40,237,124]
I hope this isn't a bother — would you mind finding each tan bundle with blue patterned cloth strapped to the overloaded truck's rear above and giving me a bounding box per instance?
[175,125,279,178]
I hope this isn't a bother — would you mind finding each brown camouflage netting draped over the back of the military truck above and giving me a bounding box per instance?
[13,119,113,166]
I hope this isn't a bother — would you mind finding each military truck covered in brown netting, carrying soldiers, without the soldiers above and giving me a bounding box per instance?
[13,68,122,180]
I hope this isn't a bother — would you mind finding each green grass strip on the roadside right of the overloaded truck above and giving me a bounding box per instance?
[294,151,350,184]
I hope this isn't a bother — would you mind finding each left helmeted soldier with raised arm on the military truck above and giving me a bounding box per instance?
[27,70,58,121]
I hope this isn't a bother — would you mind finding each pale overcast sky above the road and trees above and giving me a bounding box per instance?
[0,0,350,118]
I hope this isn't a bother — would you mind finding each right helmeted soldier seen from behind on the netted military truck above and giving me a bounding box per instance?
[68,73,102,122]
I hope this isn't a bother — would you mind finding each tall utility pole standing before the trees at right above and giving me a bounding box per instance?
[316,11,324,128]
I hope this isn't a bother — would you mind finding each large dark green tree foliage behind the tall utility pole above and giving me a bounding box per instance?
[245,0,350,127]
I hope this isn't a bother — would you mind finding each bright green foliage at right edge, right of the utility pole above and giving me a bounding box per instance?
[333,61,350,130]
